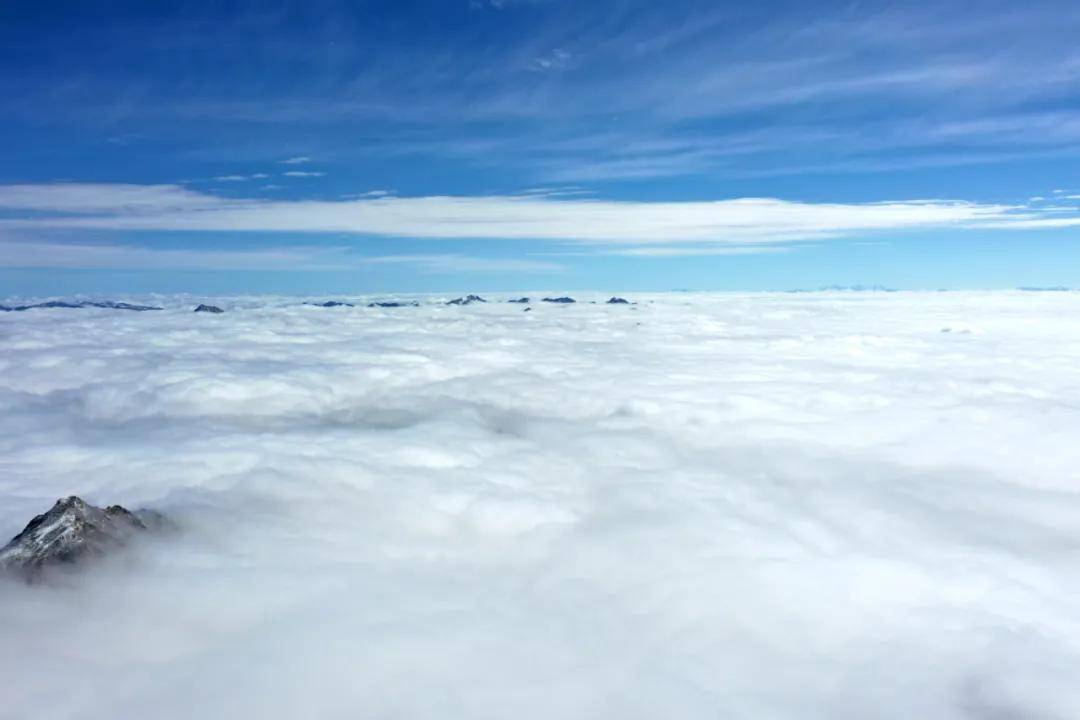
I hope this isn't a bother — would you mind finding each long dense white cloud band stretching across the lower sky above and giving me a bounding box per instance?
[0,184,1062,244]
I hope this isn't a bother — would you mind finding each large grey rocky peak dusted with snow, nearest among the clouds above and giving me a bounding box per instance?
[0,495,170,582]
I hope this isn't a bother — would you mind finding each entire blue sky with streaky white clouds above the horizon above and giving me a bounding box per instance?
[0,0,1080,295]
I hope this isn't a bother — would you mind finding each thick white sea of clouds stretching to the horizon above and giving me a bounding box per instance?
[0,291,1080,720]
